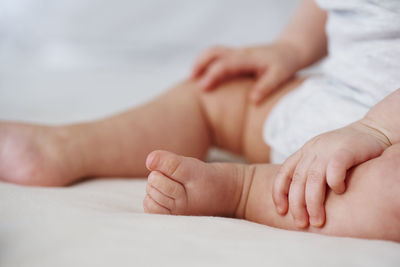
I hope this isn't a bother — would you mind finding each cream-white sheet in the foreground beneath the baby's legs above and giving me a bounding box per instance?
[0,179,400,267]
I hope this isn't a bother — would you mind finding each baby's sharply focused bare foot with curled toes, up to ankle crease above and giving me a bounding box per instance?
[143,151,251,217]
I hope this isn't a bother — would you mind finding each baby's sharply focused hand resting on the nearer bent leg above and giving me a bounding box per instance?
[273,119,391,228]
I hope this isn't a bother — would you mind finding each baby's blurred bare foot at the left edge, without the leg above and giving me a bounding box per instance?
[0,122,81,186]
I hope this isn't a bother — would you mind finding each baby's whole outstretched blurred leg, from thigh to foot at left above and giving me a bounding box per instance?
[0,79,299,186]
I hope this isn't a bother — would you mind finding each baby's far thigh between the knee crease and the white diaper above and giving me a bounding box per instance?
[200,78,303,163]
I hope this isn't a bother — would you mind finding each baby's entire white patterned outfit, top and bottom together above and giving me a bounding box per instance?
[263,0,400,163]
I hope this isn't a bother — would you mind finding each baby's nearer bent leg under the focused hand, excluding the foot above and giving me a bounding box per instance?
[245,145,400,241]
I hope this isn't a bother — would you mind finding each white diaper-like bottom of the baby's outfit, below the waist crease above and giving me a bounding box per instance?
[263,76,372,163]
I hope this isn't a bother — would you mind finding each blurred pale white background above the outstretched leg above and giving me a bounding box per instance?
[0,0,297,123]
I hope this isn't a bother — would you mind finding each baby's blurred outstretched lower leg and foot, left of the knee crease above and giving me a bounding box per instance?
[0,82,210,186]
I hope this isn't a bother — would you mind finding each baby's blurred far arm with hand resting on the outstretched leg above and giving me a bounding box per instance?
[192,0,327,103]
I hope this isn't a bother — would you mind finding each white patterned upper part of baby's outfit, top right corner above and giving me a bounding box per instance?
[317,0,400,102]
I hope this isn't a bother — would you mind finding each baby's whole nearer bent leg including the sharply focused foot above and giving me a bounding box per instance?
[143,149,400,241]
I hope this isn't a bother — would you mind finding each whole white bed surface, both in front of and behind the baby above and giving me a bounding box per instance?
[0,0,400,267]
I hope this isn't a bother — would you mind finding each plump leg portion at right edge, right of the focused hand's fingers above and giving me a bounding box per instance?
[320,145,400,241]
